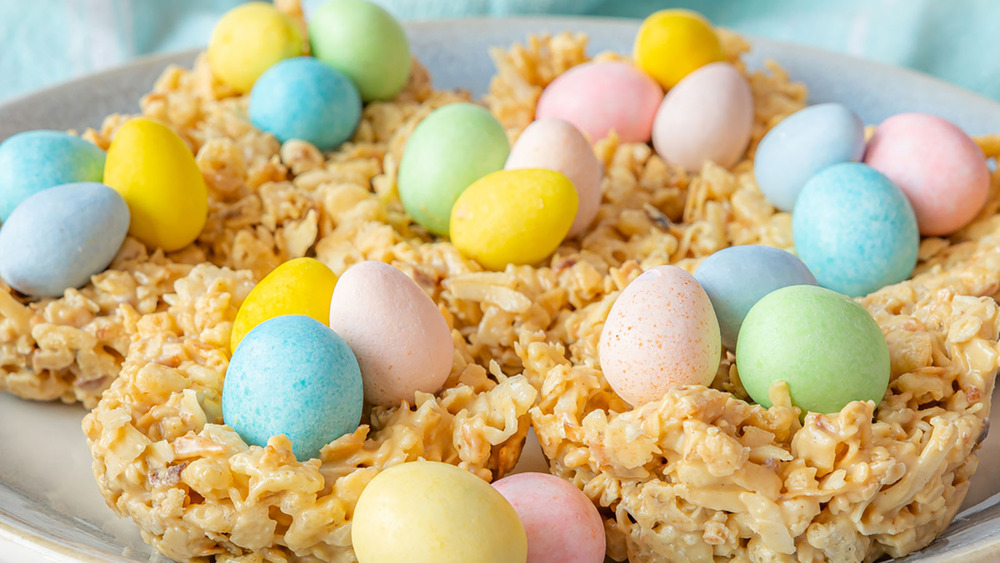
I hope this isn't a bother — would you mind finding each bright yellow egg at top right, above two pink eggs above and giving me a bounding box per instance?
[632,9,723,89]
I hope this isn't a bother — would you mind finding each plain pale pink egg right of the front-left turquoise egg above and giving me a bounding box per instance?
[330,261,455,406]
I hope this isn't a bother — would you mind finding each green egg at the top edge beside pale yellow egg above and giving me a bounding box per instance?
[309,0,412,102]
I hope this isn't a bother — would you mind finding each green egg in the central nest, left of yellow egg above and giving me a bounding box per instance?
[396,103,510,235]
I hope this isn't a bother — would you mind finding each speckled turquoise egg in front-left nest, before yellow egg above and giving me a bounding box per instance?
[222,315,364,461]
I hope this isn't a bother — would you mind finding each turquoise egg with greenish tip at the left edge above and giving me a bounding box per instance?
[0,130,105,221]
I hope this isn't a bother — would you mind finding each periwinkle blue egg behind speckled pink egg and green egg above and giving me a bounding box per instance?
[694,244,816,351]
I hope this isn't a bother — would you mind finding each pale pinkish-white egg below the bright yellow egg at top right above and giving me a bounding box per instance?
[653,63,754,172]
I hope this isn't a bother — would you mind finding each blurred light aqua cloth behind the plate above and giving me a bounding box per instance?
[0,0,1000,102]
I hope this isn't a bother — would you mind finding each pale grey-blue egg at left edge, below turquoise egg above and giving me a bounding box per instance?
[0,182,129,297]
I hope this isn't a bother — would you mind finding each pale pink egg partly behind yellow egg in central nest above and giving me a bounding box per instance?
[504,119,604,237]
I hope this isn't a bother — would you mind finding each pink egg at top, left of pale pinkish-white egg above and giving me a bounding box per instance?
[535,61,663,143]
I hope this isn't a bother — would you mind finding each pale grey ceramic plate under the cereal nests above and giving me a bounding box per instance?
[0,18,1000,563]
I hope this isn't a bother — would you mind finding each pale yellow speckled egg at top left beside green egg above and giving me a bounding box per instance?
[208,2,303,92]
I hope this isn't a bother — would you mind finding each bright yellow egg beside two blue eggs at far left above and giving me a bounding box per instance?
[104,118,208,252]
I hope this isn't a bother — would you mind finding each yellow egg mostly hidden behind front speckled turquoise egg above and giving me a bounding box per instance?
[229,258,337,351]
